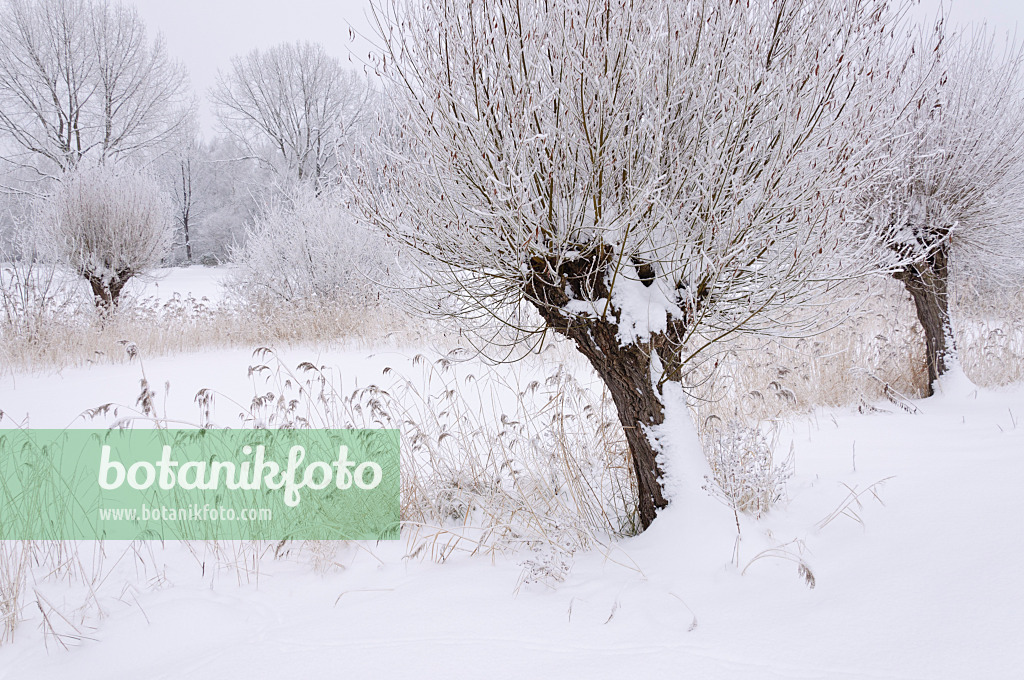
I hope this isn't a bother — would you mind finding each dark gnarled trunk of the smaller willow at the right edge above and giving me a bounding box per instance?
[895,246,956,396]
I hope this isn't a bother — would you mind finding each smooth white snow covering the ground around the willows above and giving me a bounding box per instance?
[0,268,1024,680]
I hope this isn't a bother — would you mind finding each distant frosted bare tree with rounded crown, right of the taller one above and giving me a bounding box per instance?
[211,42,373,187]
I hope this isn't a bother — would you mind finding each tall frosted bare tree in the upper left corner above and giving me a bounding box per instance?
[0,0,193,177]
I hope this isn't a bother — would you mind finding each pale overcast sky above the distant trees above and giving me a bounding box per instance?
[128,0,1024,135]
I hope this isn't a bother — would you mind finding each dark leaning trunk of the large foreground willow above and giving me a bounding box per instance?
[526,248,668,529]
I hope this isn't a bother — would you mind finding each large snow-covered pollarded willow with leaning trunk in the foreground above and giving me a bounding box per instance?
[355,0,913,527]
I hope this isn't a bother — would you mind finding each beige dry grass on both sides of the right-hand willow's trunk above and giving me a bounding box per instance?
[688,279,1024,428]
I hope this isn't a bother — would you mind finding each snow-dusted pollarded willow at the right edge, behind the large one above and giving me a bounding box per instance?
[866,22,1024,395]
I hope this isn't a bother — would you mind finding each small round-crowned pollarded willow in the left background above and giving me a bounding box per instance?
[35,166,174,312]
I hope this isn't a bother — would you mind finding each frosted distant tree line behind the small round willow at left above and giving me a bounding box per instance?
[0,0,377,304]
